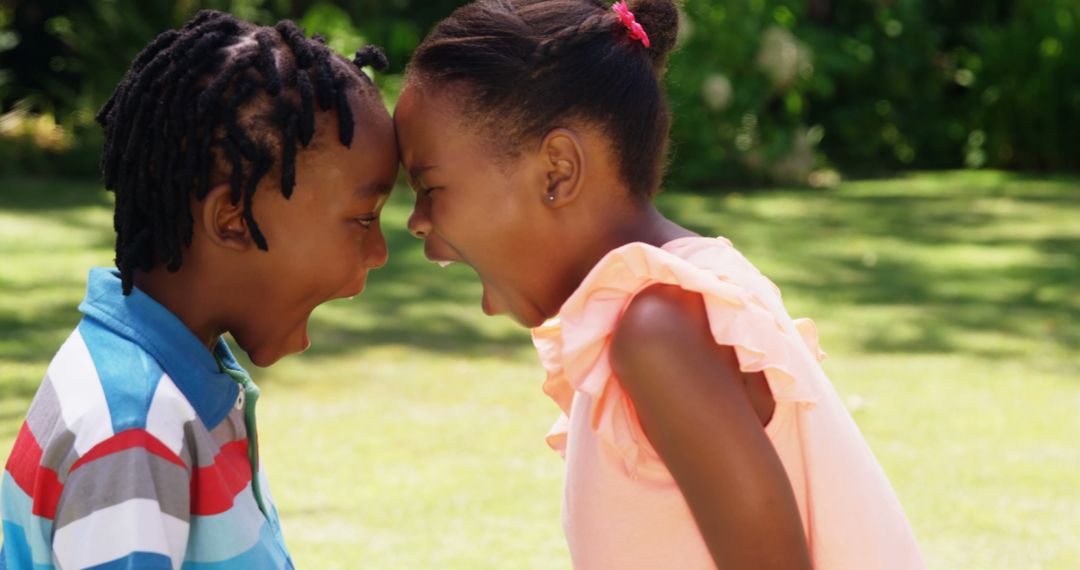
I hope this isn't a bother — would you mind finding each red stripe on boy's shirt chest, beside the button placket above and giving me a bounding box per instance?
[191,439,252,516]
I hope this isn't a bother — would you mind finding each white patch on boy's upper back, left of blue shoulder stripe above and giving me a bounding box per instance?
[48,329,112,456]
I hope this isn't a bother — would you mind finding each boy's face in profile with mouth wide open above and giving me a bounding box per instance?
[229,96,397,366]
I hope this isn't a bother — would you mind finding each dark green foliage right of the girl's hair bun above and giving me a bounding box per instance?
[670,0,1080,185]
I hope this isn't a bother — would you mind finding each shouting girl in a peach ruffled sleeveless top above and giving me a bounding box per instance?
[396,0,922,570]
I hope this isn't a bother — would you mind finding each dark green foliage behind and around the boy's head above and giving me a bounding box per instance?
[0,0,462,176]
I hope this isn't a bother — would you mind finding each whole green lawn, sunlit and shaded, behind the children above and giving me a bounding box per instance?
[0,172,1080,569]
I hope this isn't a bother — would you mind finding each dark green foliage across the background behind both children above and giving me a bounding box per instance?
[0,0,1080,182]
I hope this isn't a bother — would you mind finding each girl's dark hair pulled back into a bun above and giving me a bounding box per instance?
[409,0,678,196]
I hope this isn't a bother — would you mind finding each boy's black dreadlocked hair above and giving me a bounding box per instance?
[97,11,387,295]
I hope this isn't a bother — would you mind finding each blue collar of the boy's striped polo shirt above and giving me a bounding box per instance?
[79,268,246,429]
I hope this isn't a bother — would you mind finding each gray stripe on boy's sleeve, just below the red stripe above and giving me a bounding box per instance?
[54,447,191,532]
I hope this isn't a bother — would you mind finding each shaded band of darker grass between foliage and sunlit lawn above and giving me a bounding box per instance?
[0,173,1080,397]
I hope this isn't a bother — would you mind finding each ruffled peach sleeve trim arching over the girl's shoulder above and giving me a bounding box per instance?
[544,238,824,401]
